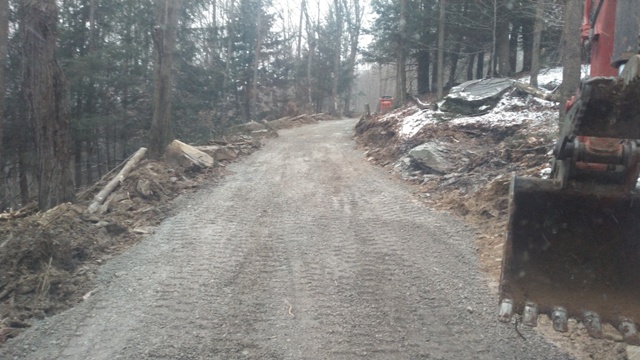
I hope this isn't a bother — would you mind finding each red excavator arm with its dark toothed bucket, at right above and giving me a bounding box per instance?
[498,0,640,345]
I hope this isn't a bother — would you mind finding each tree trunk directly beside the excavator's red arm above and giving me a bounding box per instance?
[560,0,583,119]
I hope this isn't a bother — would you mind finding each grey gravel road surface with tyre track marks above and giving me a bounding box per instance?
[0,120,569,360]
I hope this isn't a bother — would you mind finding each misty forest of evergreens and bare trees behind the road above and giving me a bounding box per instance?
[0,0,568,210]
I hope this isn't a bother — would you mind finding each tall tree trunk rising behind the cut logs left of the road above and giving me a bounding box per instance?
[149,0,182,159]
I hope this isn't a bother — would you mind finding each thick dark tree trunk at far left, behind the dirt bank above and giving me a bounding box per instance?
[20,0,75,210]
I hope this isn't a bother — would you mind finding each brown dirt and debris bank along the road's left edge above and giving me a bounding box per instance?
[0,136,260,344]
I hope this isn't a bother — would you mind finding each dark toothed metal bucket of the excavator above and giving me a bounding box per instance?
[500,176,640,344]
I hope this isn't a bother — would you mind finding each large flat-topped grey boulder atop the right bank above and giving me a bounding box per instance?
[440,78,515,115]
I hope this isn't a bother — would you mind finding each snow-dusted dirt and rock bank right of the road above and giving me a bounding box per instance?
[356,99,640,359]
